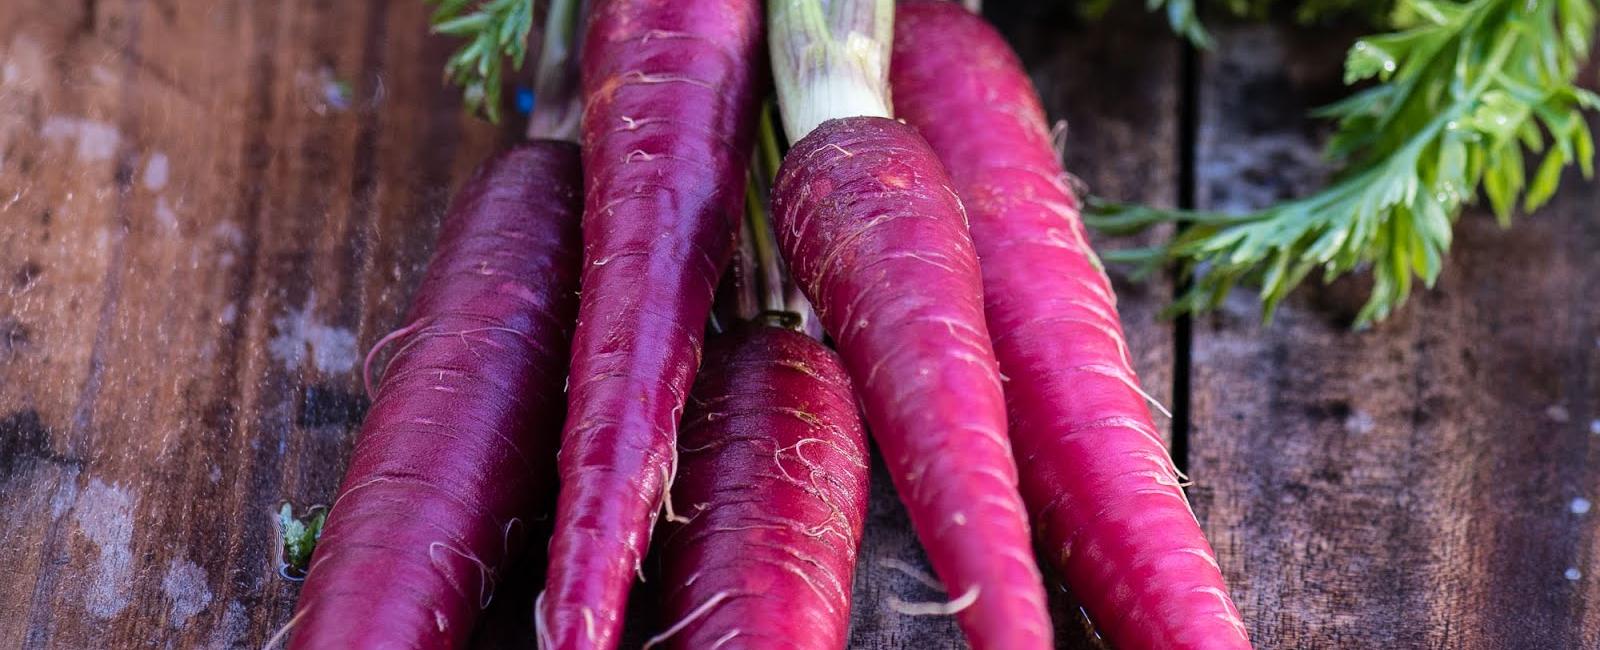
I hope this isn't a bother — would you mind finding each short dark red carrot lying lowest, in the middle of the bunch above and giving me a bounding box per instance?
[661,325,869,650]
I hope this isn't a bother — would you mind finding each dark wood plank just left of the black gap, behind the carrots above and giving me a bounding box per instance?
[851,2,1179,650]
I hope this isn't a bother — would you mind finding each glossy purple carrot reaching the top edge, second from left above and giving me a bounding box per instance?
[534,0,762,648]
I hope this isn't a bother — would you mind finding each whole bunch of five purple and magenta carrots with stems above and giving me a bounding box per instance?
[282,0,1250,650]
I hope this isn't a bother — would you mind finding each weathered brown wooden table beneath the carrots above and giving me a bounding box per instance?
[0,0,1600,648]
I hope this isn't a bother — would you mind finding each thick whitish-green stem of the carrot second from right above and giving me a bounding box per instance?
[768,0,894,142]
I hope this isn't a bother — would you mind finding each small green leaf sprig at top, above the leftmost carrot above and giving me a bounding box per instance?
[429,0,533,123]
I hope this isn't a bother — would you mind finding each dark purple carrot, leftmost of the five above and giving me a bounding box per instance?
[290,141,581,648]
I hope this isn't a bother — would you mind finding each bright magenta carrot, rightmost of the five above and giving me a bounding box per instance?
[890,2,1250,650]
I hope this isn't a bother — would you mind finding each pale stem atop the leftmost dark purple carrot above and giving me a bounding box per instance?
[528,0,582,142]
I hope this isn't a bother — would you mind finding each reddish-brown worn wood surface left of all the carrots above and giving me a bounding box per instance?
[0,0,499,647]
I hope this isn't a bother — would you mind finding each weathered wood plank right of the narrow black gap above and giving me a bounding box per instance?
[1190,27,1600,648]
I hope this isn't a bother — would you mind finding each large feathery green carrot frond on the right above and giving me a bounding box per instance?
[1086,0,1600,327]
